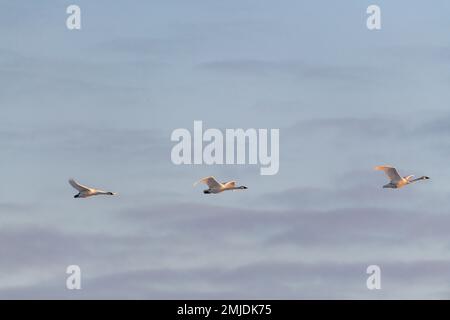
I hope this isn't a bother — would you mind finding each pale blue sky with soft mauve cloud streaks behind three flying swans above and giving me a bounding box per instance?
[0,0,450,299]
